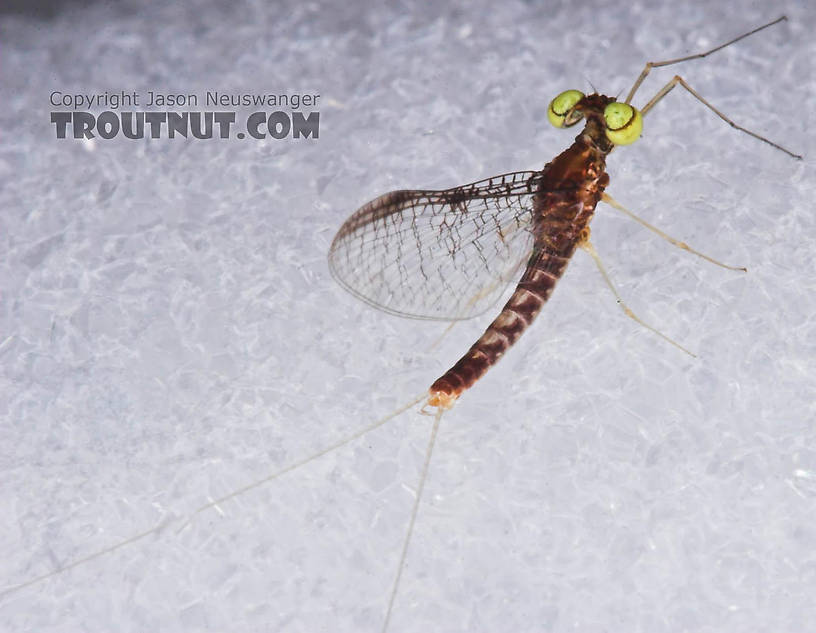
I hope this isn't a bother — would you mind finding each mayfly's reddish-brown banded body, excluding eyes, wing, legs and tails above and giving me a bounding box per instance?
[428,95,614,408]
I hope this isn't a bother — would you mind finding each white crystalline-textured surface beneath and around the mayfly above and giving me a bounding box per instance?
[0,1,816,633]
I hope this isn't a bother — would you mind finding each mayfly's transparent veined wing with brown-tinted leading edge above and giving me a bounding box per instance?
[329,171,541,320]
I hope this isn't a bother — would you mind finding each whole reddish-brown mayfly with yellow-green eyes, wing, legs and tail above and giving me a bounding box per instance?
[329,16,801,631]
